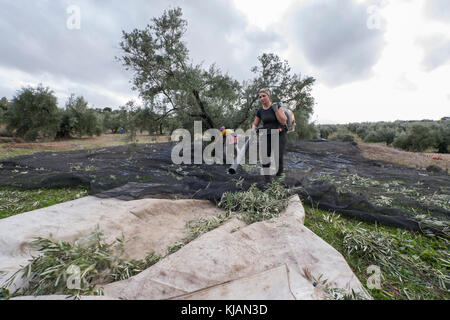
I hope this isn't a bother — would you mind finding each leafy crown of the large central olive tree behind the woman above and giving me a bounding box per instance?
[119,8,315,135]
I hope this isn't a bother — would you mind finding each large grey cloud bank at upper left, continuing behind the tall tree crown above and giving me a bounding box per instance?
[0,0,279,105]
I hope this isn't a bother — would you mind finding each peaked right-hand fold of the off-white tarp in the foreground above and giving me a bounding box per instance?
[104,197,370,300]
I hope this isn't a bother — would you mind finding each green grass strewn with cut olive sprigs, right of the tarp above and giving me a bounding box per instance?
[305,205,450,300]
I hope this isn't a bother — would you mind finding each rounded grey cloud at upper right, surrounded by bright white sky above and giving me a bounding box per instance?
[289,0,384,86]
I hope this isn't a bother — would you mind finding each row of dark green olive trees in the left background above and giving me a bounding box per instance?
[0,84,168,141]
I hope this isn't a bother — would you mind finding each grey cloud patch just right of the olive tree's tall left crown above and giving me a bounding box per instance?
[177,0,280,81]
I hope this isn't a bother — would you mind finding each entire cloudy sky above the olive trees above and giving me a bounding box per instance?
[0,0,450,124]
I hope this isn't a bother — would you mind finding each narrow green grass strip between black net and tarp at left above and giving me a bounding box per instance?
[0,187,89,219]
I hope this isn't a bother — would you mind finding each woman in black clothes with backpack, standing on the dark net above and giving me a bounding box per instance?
[252,88,287,176]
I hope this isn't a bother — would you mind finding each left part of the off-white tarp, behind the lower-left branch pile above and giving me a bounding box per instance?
[0,196,223,290]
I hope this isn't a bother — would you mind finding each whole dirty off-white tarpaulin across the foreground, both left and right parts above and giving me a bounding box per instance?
[0,196,370,299]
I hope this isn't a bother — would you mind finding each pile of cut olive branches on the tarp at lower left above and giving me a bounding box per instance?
[0,230,161,298]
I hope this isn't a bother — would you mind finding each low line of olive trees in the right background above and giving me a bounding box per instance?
[317,117,450,153]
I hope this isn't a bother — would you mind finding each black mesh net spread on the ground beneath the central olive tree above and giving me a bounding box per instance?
[0,140,450,233]
